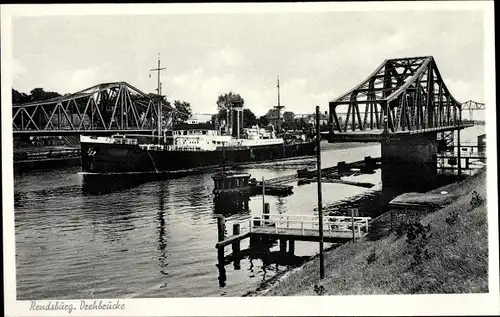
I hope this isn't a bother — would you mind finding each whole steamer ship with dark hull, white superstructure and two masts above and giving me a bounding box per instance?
[80,59,315,175]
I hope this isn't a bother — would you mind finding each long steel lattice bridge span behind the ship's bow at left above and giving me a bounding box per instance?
[12,82,173,135]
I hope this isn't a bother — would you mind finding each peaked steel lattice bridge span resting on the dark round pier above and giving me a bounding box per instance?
[329,56,460,133]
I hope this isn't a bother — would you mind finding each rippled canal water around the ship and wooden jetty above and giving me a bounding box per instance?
[14,128,483,300]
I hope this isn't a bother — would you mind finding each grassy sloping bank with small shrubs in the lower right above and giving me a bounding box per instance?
[260,170,488,296]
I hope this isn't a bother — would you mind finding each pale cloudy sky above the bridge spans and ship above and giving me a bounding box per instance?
[12,11,485,115]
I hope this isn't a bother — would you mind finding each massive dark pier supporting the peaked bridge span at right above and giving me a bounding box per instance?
[381,133,437,191]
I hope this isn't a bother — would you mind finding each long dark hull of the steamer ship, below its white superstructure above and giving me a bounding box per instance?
[81,142,315,174]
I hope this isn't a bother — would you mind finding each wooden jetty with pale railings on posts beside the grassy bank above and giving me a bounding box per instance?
[215,203,371,260]
